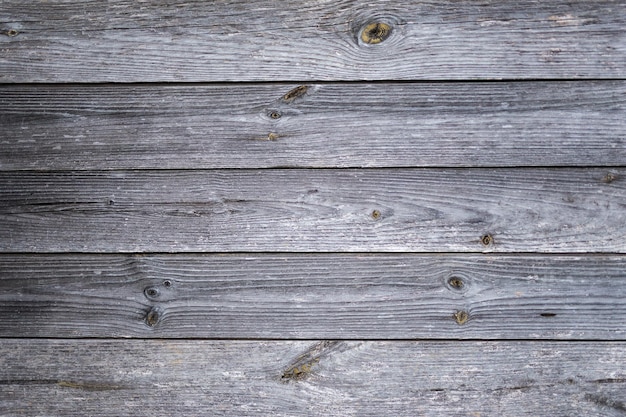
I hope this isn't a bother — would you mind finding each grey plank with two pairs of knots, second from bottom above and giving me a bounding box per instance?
[0,254,626,340]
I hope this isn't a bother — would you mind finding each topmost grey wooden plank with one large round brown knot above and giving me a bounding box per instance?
[0,0,626,82]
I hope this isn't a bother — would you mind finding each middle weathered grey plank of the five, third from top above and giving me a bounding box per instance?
[0,168,626,253]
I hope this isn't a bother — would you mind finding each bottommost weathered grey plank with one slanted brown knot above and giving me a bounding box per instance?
[0,339,626,417]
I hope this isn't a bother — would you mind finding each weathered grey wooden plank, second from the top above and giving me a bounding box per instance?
[0,81,626,170]
